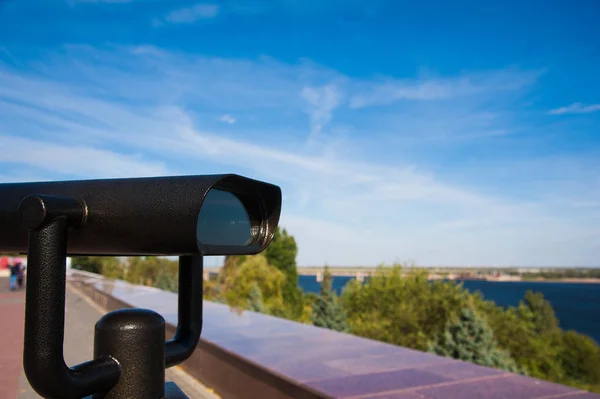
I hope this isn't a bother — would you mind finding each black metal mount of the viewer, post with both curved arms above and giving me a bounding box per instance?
[19,195,203,399]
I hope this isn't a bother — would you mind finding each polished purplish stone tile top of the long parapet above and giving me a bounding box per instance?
[71,271,600,399]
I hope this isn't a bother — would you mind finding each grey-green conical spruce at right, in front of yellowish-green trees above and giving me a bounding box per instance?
[429,307,517,372]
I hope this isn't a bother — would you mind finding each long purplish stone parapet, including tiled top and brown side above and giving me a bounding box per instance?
[68,270,600,399]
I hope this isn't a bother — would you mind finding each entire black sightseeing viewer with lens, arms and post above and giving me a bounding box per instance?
[0,175,281,399]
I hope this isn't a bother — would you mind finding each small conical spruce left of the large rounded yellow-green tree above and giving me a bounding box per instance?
[312,266,349,332]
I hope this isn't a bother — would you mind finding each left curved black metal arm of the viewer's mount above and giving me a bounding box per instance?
[23,198,119,398]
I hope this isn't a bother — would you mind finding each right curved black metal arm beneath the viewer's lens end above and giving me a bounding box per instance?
[165,256,203,368]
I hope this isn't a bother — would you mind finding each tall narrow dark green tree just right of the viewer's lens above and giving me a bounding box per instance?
[265,227,303,319]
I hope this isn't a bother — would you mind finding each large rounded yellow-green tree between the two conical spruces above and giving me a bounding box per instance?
[341,266,469,350]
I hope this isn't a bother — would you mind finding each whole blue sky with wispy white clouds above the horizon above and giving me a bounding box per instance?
[0,0,600,266]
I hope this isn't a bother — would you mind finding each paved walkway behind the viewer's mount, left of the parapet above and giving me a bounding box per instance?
[0,278,218,399]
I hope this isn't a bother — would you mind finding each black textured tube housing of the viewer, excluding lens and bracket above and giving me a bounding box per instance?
[0,175,281,256]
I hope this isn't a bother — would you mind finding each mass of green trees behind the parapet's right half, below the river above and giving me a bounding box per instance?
[341,266,600,392]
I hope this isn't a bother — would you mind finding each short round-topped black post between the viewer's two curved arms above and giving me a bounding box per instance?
[94,309,165,399]
